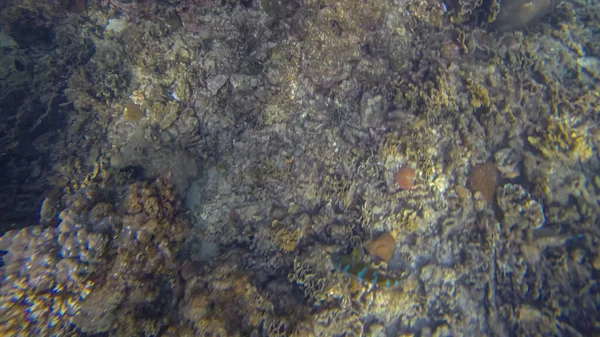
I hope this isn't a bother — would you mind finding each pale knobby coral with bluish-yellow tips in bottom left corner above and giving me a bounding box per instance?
[0,211,99,336]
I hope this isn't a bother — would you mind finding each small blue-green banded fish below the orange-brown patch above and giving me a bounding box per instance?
[332,249,400,288]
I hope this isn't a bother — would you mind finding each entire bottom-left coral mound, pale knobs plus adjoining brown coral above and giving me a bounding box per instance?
[0,179,189,336]
